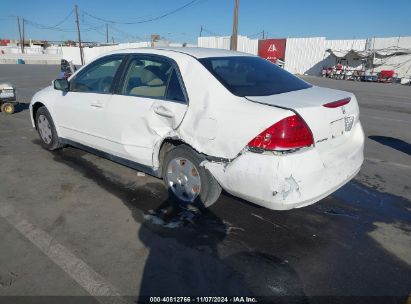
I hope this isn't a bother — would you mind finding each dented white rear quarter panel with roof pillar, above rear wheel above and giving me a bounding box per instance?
[163,57,292,159]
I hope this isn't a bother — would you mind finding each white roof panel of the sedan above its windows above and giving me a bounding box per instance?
[111,47,254,58]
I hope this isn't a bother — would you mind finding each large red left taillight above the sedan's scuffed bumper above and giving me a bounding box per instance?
[248,115,314,150]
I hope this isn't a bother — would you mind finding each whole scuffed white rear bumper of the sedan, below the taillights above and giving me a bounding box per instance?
[204,122,364,210]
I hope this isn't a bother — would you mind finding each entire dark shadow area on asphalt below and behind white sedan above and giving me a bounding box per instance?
[30,141,411,303]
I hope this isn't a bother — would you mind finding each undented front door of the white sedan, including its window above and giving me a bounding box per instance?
[55,55,124,149]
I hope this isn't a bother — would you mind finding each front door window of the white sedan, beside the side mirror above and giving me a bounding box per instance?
[70,56,122,94]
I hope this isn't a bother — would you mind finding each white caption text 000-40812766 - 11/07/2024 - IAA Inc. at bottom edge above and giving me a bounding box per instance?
[149,297,258,303]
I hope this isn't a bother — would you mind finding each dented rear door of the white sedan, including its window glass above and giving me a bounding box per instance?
[106,55,188,166]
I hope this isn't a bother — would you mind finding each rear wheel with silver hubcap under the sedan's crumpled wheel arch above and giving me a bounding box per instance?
[162,145,221,208]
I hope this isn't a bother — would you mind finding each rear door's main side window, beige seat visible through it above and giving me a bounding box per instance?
[120,58,173,99]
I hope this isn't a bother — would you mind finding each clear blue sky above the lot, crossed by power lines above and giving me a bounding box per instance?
[0,0,411,43]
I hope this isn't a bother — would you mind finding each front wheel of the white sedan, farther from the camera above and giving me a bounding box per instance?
[36,107,63,151]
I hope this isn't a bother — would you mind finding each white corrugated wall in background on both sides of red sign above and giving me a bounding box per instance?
[198,36,411,77]
